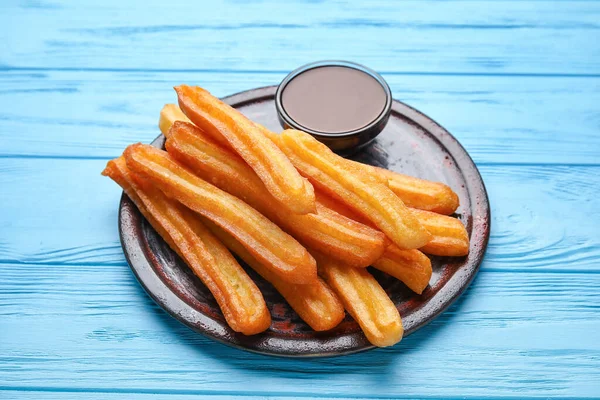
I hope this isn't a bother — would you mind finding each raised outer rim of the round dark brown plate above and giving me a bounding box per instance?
[118,85,491,358]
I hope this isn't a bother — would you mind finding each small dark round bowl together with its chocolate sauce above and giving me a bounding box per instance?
[275,61,392,155]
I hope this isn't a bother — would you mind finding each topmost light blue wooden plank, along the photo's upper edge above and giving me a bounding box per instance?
[0,0,600,76]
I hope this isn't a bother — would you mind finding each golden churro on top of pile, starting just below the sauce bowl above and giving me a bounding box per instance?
[280,129,431,249]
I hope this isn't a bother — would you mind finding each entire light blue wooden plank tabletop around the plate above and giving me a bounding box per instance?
[0,0,600,400]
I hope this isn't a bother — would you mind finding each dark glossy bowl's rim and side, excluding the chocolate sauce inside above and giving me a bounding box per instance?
[275,61,392,155]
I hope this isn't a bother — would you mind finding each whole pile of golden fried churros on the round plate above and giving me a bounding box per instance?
[103,85,469,347]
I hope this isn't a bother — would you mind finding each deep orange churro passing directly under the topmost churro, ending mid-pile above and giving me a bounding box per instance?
[166,122,386,267]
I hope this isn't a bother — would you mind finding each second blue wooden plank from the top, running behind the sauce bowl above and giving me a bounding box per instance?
[0,72,600,164]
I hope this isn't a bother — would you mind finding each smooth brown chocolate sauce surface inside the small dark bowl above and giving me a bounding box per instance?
[281,66,388,134]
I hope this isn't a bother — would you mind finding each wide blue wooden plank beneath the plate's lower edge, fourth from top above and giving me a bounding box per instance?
[0,264,600,398]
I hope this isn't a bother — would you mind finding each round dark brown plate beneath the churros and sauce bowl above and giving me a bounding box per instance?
[119,86,490,357]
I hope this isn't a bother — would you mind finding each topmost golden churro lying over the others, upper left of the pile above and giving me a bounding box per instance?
[175,85,316,214]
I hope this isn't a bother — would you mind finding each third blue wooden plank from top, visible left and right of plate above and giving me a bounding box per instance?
[0,158,600,272]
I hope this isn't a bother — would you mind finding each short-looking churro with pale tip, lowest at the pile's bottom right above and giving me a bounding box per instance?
[313,253,404,347]
